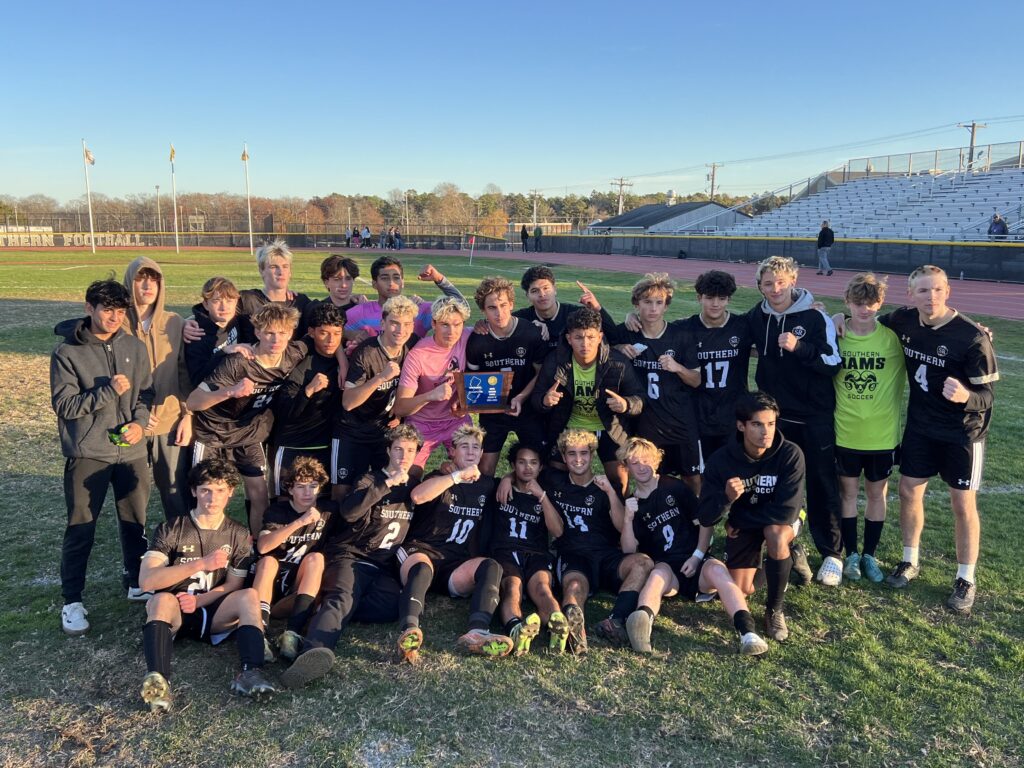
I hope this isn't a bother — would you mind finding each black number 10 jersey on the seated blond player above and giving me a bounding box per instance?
[408,472,495,559]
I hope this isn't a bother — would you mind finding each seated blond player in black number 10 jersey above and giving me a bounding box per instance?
[397,424,516,663]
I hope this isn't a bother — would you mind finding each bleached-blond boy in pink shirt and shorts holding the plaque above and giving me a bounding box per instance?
[394,296,472,473]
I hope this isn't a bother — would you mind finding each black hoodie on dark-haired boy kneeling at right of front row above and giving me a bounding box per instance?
[697,430,805,528]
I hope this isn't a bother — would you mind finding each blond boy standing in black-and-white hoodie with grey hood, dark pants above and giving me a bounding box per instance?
[746,256,843,587]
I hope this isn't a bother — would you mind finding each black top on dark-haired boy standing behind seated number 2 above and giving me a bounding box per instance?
[270,349,341,447]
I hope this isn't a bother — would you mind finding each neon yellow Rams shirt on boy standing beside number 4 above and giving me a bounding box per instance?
[834,323,906,451]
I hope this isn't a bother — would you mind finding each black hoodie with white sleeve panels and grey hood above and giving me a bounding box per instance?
[746,288,843,423]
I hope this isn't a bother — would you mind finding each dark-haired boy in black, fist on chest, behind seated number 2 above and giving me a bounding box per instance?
[270,302,345,497]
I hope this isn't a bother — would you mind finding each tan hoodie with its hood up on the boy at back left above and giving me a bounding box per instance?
[124,256,191,436]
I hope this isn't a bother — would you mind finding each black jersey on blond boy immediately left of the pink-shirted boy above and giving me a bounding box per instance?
[335,334,420,439]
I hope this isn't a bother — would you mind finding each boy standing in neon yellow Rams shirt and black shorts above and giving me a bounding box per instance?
[834,272,905,582]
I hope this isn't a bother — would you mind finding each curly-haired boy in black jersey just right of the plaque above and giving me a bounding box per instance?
[466,278,549,475]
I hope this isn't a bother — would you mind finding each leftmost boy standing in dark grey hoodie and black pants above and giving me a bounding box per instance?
[50,280,154,635]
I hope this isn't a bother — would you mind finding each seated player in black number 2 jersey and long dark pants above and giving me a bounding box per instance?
[281,424,422,688]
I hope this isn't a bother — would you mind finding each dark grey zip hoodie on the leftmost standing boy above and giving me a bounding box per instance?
[50,317,154,464]
